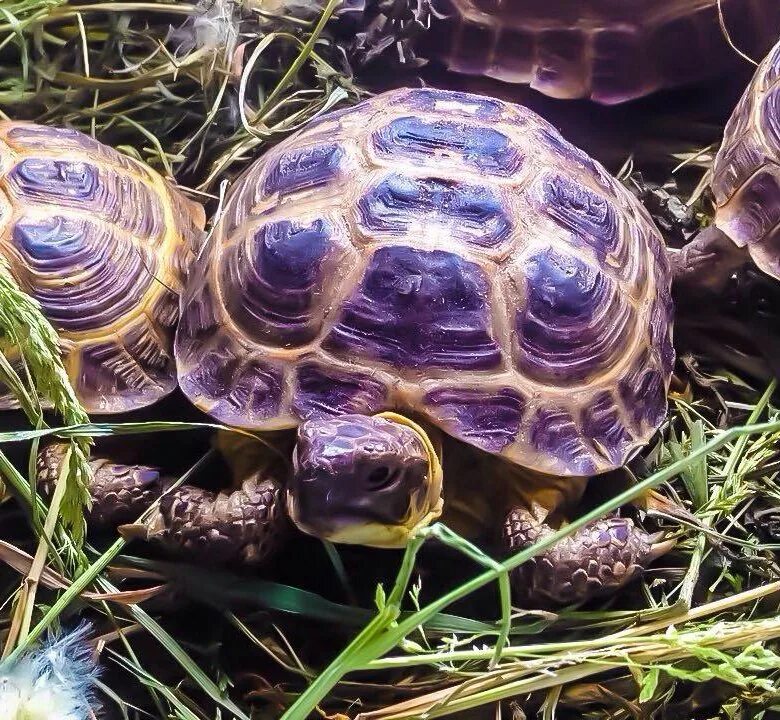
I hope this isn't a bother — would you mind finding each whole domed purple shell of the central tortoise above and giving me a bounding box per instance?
[175,89,674,475]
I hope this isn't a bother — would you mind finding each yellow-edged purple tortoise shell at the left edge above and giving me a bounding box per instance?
[0,122,205,413]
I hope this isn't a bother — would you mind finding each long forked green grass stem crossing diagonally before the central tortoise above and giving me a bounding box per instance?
[280,421,780,720]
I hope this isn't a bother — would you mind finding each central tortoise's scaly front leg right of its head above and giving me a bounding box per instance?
[504,508,674,607]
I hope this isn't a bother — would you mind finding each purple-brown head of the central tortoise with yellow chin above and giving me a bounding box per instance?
[287,413,442,547]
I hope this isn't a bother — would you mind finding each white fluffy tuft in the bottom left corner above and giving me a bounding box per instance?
[0,625,97,720]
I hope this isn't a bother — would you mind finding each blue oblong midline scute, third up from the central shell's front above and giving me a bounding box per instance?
[373,117,523,176]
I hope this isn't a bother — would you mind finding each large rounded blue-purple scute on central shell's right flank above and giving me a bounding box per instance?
[515,248,635,385]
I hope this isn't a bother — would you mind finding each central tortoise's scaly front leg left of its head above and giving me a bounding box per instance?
[37,443,287,563]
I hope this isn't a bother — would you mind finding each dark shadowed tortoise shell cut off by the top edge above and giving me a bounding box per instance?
[418,0,780,103]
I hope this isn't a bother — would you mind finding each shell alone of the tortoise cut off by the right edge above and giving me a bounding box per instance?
[711,38,780,280]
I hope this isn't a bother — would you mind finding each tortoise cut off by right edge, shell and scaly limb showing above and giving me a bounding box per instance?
[674,36,780,291]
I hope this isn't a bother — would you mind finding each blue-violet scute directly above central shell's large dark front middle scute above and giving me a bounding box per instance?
[358,174,512,248]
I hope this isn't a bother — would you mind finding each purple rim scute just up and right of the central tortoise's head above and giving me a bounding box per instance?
[424,388,526,453]
